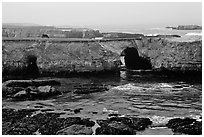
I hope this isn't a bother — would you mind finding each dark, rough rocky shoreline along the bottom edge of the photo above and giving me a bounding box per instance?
[2,108,202,135]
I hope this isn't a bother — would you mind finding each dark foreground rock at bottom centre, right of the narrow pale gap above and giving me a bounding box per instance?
[96,116,152,135]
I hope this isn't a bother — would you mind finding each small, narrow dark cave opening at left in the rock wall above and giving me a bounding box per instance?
[26,55,39,77]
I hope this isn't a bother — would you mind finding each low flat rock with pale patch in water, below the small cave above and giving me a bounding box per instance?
[2,80,61,100]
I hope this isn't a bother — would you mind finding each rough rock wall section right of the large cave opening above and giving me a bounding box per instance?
[135,37,202,72]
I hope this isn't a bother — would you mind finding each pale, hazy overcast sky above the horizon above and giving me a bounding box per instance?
[2,2,202,26]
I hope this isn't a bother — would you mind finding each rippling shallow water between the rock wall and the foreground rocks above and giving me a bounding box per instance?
[2,71,202,134]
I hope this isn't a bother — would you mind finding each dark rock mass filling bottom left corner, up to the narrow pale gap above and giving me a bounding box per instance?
[2,109,95,135]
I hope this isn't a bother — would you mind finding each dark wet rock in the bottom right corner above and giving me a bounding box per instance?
[166,118,202,135]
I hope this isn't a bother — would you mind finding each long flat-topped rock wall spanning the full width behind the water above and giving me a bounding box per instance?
[2,37,202,77]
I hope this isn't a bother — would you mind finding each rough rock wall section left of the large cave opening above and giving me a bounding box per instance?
[3,40,122,76]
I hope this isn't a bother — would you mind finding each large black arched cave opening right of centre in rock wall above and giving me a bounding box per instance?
[121,47,152,70]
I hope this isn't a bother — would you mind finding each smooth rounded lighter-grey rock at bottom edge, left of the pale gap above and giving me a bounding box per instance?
[57,125,93,135]
